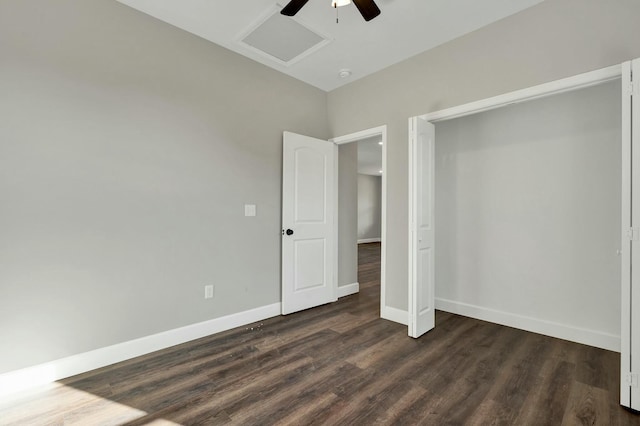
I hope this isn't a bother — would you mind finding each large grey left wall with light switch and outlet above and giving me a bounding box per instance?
[0,0,329,373]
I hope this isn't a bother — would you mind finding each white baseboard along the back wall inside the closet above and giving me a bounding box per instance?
[436,298,620,352]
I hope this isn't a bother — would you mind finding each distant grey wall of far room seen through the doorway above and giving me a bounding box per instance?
[358,174,382,240]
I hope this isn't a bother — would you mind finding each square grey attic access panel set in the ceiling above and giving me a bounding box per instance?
[240,11,330,65]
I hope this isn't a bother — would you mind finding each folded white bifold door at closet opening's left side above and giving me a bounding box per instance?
[409,117,435,337]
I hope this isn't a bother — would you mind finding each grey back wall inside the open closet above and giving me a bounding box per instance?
[435,81,621,336]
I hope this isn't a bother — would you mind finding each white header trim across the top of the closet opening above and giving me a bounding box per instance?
[420,65,622,122]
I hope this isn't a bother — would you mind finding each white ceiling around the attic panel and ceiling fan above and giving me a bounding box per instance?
[118,0,543,91]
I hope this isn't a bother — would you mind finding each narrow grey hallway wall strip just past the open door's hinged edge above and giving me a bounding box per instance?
[338,143,358,286]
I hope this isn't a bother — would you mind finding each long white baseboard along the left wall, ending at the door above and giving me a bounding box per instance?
[0,303,282,397]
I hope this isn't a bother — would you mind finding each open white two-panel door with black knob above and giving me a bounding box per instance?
[282,132,337,315]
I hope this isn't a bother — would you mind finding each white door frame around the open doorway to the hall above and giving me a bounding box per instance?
[329,124,390,319]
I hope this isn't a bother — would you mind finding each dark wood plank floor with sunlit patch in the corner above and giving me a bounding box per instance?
[0,244,640,426]
